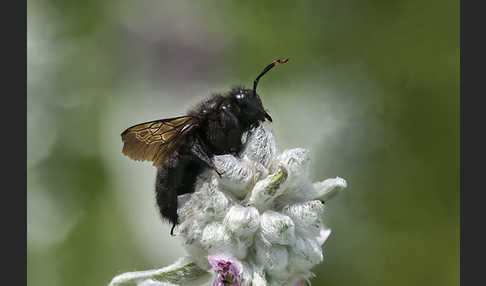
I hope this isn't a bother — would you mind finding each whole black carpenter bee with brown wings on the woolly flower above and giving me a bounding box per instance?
[121,59,288,235]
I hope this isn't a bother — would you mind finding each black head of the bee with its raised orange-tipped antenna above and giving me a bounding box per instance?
[233,59,289,122]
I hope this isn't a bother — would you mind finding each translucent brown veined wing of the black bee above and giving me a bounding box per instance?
[121,116,197,166]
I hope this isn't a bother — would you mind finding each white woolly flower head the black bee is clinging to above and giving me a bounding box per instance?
[176,126,346,285]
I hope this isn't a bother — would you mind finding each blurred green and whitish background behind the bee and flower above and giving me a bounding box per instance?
[27,0,459,286]
